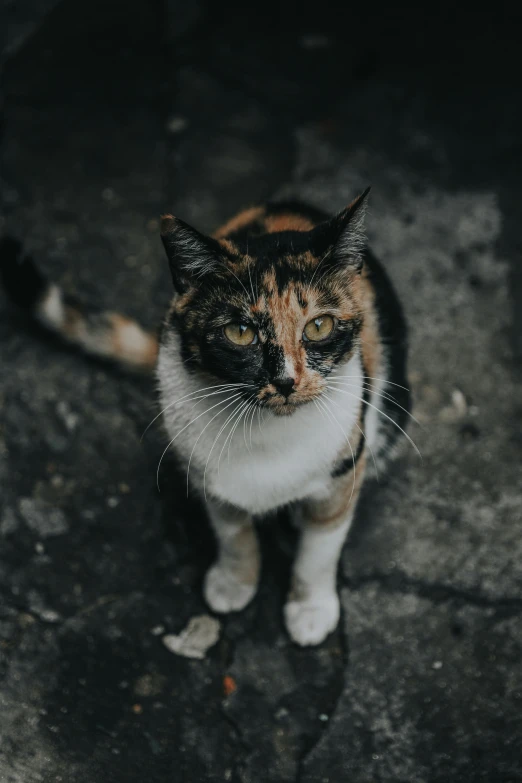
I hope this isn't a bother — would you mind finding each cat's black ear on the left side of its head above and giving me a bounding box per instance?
[161,215,219,293]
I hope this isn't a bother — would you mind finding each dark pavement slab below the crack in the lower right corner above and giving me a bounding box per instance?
[301,584,522,783]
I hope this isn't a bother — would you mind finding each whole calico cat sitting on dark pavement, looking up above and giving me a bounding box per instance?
[0,190,410,645]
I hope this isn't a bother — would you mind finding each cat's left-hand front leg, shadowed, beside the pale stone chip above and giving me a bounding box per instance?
[203,501,260,613]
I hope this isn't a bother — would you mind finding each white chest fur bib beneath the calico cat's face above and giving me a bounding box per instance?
[158,342,362,514]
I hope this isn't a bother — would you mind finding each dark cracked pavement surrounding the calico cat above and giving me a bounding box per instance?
[0,0,522,783]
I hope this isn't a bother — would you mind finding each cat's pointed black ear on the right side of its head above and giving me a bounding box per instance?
[315,188,371,271]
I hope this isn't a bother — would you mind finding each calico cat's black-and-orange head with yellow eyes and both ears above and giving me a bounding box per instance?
[162,189,369,415]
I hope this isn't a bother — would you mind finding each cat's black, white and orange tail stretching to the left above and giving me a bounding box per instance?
[0,237,158,372]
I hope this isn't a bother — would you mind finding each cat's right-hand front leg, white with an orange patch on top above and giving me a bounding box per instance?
[284,456,365,646]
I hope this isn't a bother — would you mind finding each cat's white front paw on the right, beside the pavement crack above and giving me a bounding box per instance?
[284,593,340,647]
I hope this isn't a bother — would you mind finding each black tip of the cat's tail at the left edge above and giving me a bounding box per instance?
[0,237,48,310]
